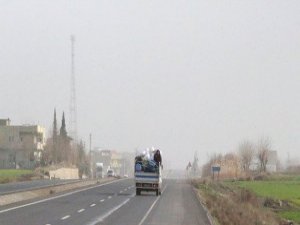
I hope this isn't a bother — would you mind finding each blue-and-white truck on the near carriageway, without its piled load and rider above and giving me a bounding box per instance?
[134,162,162,196]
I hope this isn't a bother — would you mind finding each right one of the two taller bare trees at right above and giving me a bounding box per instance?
[257,138,271,172]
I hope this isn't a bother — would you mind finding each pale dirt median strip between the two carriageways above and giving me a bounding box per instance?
[0,178,115,206]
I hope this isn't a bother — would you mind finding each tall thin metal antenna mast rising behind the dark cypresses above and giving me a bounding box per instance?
[70,35,77,143]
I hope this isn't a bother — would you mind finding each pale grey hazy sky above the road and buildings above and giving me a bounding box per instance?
[0,0,300,168]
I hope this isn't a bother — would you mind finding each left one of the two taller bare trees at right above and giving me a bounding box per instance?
[239,141,254,173]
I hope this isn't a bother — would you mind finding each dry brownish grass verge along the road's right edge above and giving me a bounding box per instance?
[193,180,279,225]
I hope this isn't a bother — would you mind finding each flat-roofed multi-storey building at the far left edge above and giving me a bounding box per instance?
[0,119,46,168]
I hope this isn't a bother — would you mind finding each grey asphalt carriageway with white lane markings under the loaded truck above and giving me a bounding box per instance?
[0,179,210,225]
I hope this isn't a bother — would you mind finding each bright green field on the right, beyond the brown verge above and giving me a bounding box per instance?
[227,176,300,223]
